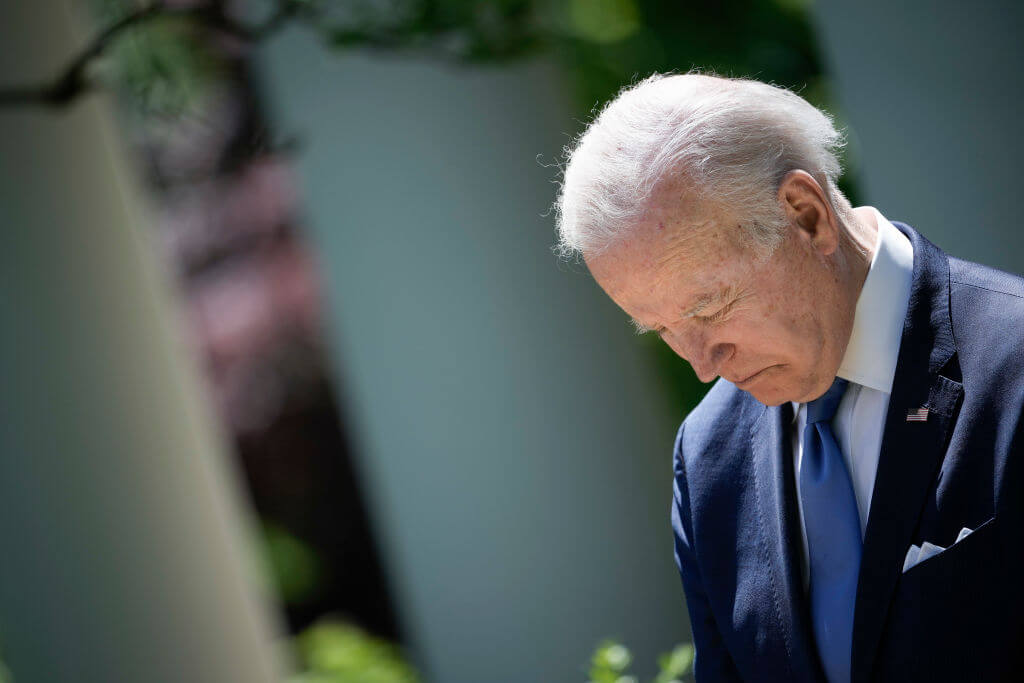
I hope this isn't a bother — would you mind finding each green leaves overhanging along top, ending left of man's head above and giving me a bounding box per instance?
[89,0,552,117]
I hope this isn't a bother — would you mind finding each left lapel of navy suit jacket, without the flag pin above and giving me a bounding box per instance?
[751,403,824,682]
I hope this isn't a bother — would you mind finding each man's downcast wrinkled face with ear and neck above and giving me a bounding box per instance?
[584,171,878,405]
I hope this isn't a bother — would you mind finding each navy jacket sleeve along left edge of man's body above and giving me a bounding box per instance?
[672,425,742,683]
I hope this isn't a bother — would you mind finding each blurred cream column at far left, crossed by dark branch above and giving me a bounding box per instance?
[0,0,288,683]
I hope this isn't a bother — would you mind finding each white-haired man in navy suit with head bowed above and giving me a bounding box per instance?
[558,75,1024,683]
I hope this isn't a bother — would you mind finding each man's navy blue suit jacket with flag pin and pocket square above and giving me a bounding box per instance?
[672,223,1024,683]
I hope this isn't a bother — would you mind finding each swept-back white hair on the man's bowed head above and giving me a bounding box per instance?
[555,74,850,256]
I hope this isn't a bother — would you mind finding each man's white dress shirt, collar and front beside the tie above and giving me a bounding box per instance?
[793,208,913,590]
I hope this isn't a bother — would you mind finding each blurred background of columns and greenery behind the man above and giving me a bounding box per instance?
[0,0,1024,683]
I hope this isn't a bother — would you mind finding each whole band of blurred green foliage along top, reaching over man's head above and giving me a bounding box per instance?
[83,0,826,126]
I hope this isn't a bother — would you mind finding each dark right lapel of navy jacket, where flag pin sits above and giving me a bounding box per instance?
[851,223,964,683]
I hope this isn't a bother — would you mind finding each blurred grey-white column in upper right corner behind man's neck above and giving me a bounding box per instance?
[813,0,1024,272]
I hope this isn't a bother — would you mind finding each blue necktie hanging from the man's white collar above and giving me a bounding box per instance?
[800,377,861,683]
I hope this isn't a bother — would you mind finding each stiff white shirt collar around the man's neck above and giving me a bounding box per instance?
[793,207,913,417]
